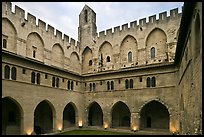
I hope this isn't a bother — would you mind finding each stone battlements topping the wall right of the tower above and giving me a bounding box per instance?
[98,8,181,39]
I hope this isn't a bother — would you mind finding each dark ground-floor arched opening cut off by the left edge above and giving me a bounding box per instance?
[2,97,23,135]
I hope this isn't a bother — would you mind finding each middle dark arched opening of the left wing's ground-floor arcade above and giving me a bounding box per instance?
[34,100,54,134]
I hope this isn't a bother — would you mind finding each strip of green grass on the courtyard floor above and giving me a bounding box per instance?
[59,130,134,135]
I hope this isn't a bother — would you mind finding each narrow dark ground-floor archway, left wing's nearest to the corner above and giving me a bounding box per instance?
[63,103,76,129]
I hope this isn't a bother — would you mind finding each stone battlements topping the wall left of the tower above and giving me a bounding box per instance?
[2,2,79,46]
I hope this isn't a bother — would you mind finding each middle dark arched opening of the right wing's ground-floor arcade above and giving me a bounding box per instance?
[112,101,130,128]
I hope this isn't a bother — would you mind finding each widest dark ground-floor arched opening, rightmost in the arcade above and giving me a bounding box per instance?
[140,100,169,129]
